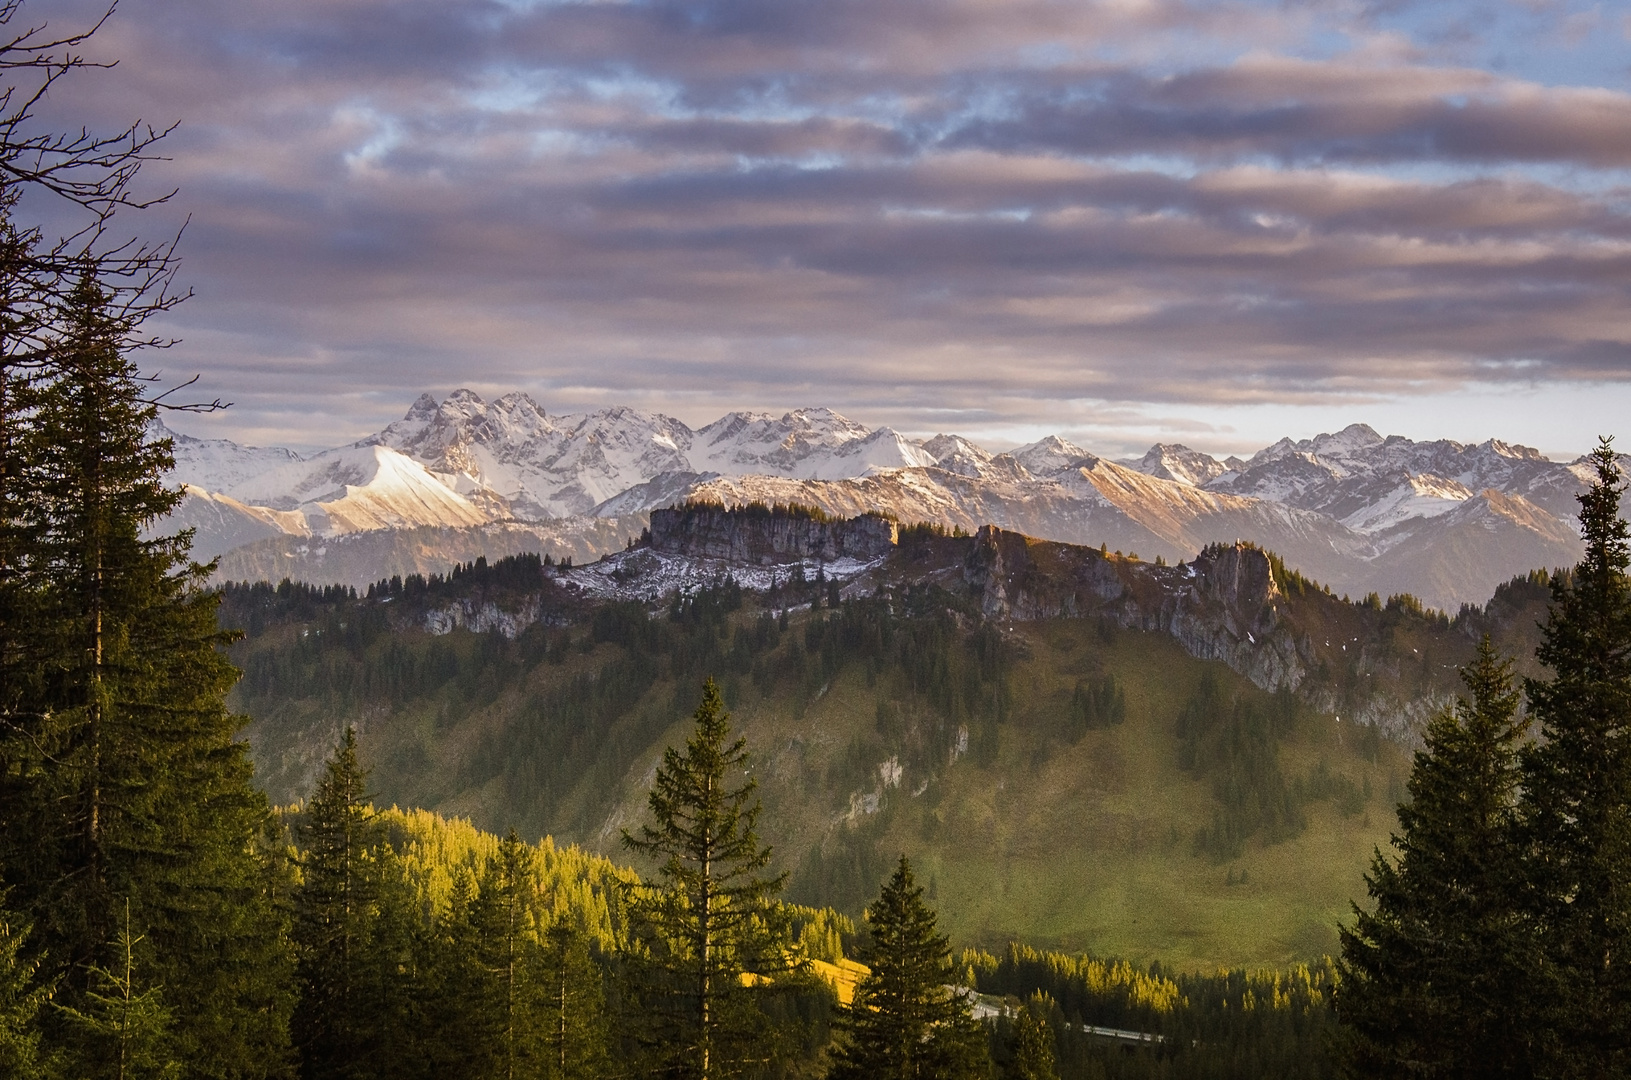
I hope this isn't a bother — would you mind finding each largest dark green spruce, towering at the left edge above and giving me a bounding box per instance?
[0,274,287,1077]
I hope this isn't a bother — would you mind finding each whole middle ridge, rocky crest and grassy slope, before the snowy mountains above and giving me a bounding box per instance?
[222,506,1546,964]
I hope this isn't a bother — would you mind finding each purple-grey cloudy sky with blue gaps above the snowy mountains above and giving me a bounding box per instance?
[15,0,1631,457]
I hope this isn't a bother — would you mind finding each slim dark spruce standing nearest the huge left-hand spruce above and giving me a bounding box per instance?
[294,728,383,1080]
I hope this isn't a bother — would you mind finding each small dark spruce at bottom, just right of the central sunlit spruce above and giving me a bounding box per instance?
[827,855,990,1080]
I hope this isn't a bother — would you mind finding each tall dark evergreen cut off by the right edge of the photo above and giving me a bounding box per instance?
[1523,439,1631,1077]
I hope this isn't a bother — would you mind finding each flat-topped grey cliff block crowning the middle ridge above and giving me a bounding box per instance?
[651,504,899,566]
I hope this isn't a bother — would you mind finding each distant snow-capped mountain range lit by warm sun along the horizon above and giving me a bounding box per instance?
[155,390,1604,610]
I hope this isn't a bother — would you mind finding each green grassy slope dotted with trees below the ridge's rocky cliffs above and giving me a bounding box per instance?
[223,554,1543,969]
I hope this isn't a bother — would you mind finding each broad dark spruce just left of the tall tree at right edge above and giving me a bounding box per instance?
[1336,636,1535,1078]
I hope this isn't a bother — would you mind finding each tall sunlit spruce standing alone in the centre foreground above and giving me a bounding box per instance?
[623,679,789,1080]
